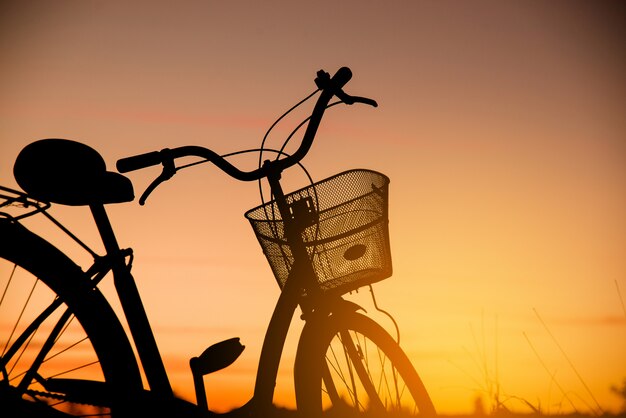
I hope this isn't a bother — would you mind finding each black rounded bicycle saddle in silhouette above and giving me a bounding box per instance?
[13,138,134,206]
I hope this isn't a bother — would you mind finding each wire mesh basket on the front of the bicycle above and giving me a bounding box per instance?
[245,169,392,294]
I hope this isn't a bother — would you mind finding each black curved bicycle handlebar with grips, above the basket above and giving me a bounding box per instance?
[116,67,378,185]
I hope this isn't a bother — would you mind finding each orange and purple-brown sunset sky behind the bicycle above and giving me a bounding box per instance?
[0,0,626,413]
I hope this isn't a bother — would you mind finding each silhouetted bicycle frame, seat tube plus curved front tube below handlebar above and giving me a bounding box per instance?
[85,172,340,408]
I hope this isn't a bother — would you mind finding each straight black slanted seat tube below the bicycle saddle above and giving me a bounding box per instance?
[89,204,173,396]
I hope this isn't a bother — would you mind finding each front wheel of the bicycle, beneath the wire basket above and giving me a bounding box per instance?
[294,311,436,417]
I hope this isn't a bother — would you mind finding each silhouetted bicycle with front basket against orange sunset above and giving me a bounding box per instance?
[0,67,435,417]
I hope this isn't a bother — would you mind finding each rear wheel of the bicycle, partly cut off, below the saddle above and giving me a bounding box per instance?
[0,220,143,417]
